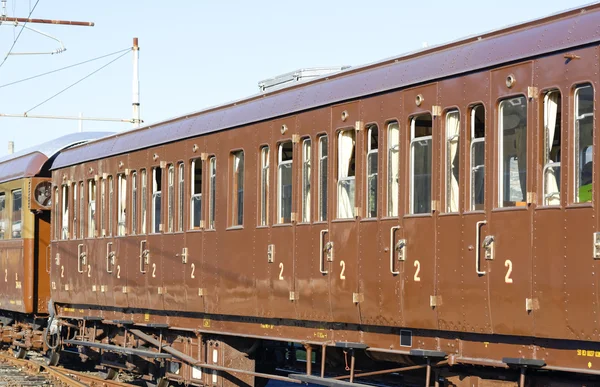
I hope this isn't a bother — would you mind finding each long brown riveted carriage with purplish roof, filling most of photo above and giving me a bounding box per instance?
[51,5,600,385]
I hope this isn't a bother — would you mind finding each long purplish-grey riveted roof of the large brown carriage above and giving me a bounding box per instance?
[53,3,600,169]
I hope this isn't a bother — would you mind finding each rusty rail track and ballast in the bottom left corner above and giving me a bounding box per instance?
[0,352,134,387]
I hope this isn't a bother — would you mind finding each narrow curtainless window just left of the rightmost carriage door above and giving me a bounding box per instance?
[470,105,485,211]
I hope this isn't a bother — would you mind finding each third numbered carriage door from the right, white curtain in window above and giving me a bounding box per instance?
[328,102,364,323]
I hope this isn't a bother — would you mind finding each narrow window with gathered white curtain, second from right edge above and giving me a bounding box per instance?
[542,90,561,206]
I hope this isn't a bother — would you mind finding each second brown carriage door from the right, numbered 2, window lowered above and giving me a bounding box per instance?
[401,84,441,329]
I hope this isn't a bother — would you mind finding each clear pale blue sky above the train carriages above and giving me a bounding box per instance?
[0,0,589,156]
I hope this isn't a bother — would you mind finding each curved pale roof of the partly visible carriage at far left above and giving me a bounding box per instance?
[0,132,113,183]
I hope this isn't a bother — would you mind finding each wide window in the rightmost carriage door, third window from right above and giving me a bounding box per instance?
[498,97,527,207]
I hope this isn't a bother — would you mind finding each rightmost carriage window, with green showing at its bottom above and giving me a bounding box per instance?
[575,85,594,203]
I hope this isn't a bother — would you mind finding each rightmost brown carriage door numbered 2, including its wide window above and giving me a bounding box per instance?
[488,63,535,335]
